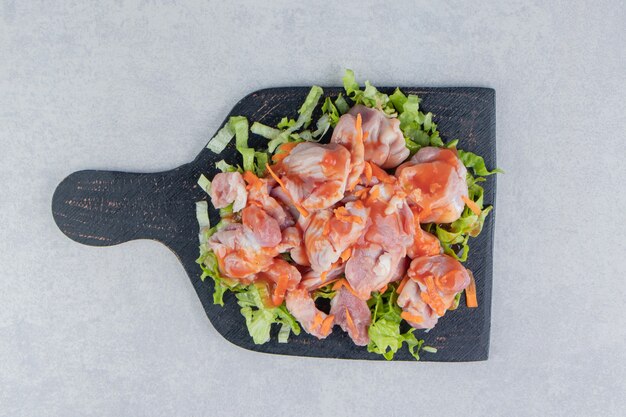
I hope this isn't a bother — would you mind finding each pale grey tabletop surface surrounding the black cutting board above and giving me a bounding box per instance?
[0,0,626,417]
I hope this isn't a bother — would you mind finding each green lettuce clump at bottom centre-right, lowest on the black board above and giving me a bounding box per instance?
[367,285,424,360]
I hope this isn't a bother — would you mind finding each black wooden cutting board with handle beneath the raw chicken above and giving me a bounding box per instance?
[52,87,496,362]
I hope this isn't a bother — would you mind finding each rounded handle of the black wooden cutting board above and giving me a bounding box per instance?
[52,166,201,248]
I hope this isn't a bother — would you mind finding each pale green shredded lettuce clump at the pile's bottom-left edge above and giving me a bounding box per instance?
[236,284,300,345]
